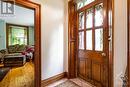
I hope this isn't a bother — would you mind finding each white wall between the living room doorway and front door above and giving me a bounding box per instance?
[32,0,68,80]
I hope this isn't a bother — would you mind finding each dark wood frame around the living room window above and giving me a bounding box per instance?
[6,23,29,48]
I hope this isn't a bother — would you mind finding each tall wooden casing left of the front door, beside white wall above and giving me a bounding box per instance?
[68,0,77,78]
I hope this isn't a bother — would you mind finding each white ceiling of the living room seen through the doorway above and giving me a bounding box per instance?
[0,5,34,26]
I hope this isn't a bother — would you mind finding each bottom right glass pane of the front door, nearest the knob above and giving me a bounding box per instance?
[95,28,103,51]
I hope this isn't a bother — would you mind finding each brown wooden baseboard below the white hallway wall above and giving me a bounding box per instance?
[41,72,67,87]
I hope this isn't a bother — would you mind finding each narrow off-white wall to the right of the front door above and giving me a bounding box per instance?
[114,0,127,87]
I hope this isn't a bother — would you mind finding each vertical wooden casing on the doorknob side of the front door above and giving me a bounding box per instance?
[108,0,114,87]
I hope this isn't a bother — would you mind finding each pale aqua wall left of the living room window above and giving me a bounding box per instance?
[0,20,6,50]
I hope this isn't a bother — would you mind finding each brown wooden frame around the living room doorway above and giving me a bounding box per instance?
[15,0,41,87]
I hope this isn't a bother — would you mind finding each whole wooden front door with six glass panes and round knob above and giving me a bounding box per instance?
[77,0,109,87]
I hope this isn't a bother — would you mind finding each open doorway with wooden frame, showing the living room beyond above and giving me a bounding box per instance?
[0,0,41,87]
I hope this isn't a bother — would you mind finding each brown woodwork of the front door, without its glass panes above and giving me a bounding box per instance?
[77,0,109,87]
